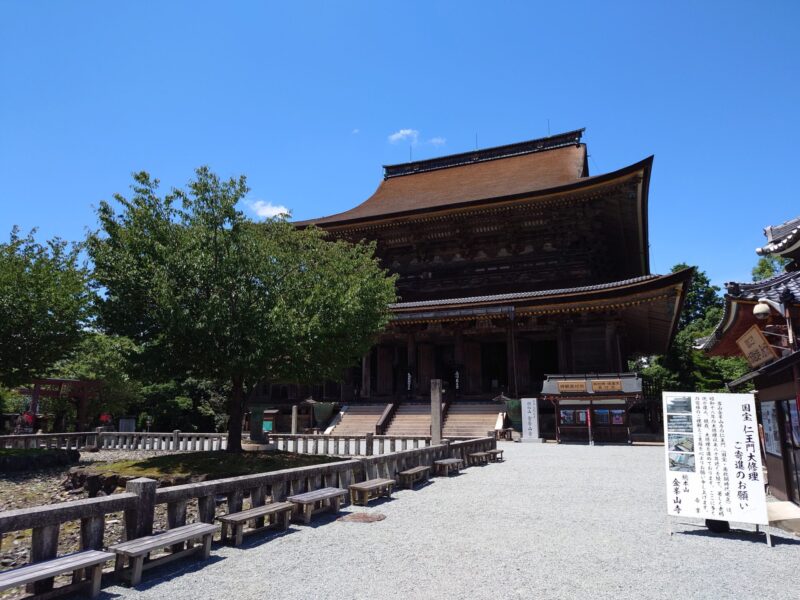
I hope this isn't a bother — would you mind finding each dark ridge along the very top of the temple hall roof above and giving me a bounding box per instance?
[383,127,586,179]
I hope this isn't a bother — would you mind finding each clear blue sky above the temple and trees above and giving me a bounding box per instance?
[0,0,800,284]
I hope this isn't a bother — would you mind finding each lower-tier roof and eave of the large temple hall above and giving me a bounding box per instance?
[390,269,694,354]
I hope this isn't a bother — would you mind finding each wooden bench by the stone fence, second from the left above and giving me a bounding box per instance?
[108,523,217,586]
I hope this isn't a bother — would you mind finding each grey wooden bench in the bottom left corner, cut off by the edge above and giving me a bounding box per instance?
[0,550,114,598]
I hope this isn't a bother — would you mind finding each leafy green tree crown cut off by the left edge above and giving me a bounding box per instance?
[0,227,91,386]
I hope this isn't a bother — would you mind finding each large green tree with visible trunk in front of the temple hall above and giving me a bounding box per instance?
[88,167,396,451]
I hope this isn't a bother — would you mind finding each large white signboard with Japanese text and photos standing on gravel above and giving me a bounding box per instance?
[663,392,767,525]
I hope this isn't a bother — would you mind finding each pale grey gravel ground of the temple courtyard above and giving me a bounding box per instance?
[103,443,800,600]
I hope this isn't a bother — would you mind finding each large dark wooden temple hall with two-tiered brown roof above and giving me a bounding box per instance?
[253,129,692,440]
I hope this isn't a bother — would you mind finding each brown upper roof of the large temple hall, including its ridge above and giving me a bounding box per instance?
[296,130,588,226]
